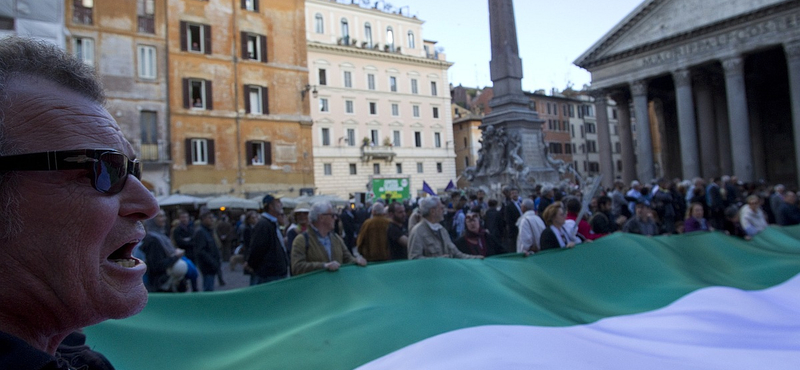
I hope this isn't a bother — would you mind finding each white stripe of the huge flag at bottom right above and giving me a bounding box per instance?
[359,275,800,370]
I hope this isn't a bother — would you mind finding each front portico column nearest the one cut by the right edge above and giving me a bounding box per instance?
[722,56,754,182]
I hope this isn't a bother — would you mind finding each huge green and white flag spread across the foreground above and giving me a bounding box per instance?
[86,227,800,370]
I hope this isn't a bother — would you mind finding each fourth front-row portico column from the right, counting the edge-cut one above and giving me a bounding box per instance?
[636,80,654,184]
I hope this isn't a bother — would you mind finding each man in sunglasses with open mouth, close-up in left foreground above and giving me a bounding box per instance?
[0,37,158,369]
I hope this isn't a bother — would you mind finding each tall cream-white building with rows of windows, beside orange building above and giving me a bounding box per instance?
[302,0,456,199]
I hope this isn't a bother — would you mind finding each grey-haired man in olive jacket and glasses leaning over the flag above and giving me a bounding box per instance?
[291,202,367,275]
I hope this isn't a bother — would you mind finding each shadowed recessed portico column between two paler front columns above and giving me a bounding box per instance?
[694,74,720,179]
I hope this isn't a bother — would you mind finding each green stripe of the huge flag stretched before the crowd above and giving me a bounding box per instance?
[86,227,800,370]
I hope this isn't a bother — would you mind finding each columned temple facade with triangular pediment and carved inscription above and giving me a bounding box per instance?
[575,0,800,186]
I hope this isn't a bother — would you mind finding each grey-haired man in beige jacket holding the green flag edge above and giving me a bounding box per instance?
[408,196,483,260]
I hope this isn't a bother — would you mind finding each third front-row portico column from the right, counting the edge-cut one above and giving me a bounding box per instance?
[672,69,700,179]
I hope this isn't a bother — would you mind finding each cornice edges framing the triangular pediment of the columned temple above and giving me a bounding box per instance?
[575,0,800,70]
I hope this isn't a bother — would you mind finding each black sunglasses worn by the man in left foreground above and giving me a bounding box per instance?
[0,149,142,195]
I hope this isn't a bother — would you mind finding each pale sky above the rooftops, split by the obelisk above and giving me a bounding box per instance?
[376,0,643,91]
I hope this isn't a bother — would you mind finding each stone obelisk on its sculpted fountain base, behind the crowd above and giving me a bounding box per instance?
[466,0,567,192]
